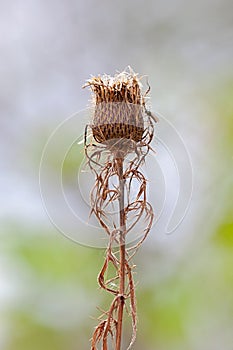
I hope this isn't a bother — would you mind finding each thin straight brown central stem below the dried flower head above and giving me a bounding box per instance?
[115,158,126,350]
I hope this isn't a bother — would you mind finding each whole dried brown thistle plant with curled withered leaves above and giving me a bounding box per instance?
[84,68,157,350]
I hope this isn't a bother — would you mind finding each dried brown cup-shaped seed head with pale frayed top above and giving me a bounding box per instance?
[84,69,145,143]
